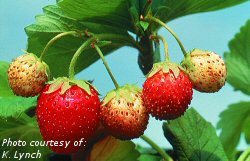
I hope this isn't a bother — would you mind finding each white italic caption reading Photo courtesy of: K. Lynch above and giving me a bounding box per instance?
[0,138,84,160]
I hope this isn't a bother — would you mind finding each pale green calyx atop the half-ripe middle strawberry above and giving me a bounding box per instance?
[102,84,142,106]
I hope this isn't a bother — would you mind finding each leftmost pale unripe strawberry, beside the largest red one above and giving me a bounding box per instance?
[8,53,48,97]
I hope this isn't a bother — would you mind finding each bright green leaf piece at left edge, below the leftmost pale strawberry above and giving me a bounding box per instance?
[0,97,37,118]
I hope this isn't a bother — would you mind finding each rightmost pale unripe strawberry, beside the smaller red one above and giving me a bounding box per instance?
[182,49,227,93]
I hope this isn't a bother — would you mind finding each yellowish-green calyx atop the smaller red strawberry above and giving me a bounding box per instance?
[147,61,183,78]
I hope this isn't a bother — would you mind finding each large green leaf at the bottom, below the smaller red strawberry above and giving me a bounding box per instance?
[163,108,228,161]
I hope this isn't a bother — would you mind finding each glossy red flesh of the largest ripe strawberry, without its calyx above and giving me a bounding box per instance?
[36,85,101,154]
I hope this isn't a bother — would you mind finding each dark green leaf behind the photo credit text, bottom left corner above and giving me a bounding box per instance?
[0,114,51,161]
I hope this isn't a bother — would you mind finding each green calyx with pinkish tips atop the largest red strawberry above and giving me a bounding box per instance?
[45,77,92,95]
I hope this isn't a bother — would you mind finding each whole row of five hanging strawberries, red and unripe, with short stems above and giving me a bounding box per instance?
[8,17,226,153]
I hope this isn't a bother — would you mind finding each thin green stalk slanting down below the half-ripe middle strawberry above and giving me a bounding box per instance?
[141,135,174,161]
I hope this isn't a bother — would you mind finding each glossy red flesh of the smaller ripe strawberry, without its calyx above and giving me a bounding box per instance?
[142,70,193,120]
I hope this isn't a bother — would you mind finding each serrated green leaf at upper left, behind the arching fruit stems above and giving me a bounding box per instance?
[25,6,135,77]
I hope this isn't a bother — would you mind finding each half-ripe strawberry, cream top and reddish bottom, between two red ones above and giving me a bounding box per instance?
[100,85,149,140]
